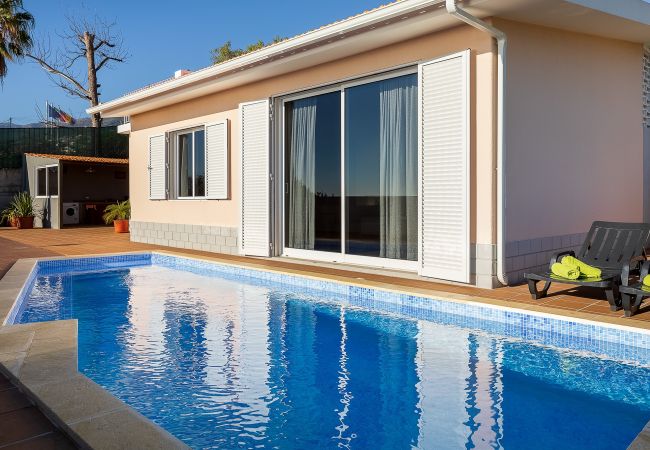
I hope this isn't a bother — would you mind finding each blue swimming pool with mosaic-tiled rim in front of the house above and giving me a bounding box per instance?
[11,254,650,449]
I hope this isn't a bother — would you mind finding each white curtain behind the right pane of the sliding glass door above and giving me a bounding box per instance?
[379,77,418,260]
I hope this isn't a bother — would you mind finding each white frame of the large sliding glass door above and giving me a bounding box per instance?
[273,64,420,272]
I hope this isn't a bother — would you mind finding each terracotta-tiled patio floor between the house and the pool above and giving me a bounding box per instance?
[0,227,650,328]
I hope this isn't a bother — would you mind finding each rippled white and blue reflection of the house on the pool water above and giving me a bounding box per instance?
[121,268,503,448]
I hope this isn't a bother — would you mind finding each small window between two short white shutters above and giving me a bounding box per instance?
[175,128,205,198]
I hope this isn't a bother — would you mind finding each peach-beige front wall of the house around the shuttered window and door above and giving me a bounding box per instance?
[129,26,495,244]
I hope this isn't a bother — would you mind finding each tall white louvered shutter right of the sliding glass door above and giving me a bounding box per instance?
[419,51,470,283]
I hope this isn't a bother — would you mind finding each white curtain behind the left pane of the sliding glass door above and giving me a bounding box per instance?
[288,98,317,250]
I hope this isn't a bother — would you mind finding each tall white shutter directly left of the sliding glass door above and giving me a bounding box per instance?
[239,100,270,256]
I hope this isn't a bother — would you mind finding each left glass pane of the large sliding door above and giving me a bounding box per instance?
[284,92,341,252]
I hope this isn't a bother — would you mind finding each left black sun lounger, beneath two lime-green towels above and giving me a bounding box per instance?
[524,222,650,311]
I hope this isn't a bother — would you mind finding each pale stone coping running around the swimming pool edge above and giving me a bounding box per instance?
[0,250,650,450]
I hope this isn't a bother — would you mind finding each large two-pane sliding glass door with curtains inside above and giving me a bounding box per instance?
[283,73,418,270]
